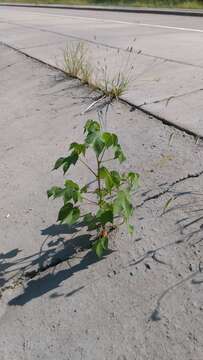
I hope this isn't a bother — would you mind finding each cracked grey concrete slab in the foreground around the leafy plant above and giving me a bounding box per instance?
[0,46,203,360]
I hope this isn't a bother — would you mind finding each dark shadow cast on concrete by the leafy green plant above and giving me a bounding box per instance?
[0,223,104,305]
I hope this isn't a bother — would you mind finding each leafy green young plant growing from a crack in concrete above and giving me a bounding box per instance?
[47,120,139,257]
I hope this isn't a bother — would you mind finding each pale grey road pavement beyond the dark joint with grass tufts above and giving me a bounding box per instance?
[0,6,203,136]
